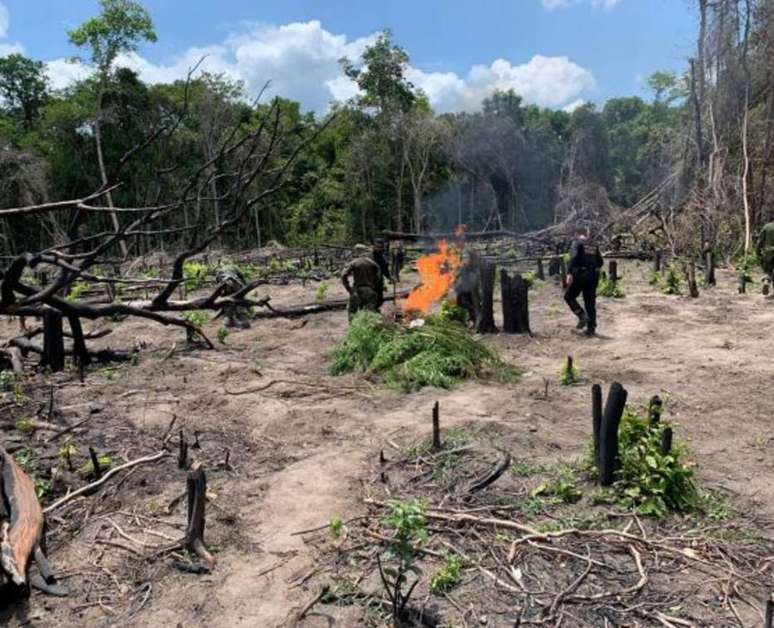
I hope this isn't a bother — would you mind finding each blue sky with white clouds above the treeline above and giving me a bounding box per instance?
[0,0,696,111]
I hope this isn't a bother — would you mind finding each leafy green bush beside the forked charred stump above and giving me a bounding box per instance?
[614,406,702,517]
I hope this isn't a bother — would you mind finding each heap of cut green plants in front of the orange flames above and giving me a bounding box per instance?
[330,310,518,391]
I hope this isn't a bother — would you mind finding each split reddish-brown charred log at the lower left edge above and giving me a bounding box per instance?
[0,448,43,596]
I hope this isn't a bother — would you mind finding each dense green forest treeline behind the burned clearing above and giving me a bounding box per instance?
[0,0,774,255]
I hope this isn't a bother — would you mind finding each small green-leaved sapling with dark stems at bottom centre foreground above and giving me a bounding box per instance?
[377,501,429,627]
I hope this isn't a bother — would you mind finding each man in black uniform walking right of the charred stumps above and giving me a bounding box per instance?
[564,234,603,336]
